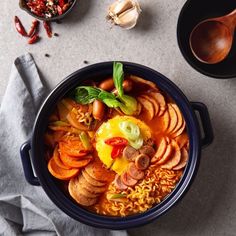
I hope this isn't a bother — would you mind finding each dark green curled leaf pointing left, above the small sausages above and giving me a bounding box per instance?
[74,86,100,104]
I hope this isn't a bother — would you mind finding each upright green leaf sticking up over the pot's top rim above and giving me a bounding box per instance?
[113,62,124,97]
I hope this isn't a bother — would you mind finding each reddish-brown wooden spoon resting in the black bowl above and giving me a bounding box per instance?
[189,9,236,64]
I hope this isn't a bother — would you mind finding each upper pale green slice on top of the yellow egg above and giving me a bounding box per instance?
[119,121,140,140]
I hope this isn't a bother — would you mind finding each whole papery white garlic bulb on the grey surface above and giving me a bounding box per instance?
[108,0,141,29]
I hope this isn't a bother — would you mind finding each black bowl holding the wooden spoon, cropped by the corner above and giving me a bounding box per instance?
[177,0,236,79]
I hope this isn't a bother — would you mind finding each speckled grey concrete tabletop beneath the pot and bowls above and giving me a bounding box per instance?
[0,0,236,236]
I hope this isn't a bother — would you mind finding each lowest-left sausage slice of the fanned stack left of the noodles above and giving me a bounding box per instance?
[68,177,98,206]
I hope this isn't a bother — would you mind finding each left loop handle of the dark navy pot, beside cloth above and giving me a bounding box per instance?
[20,141,40,186]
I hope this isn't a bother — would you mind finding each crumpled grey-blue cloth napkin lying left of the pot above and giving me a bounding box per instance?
[0,54,127,236]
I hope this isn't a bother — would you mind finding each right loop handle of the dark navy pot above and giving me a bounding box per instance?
[190,102,214,147]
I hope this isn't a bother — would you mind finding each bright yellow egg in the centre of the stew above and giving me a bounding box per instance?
[95,116,152,174]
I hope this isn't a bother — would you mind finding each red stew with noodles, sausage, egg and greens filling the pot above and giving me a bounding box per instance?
[45,63,189,217]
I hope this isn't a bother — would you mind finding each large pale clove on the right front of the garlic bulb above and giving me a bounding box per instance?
[114,7,139,29]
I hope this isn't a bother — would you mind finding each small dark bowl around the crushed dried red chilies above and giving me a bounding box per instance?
[19,0,77,21]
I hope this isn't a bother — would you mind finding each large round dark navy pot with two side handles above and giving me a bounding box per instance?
[21,62,213,229]
